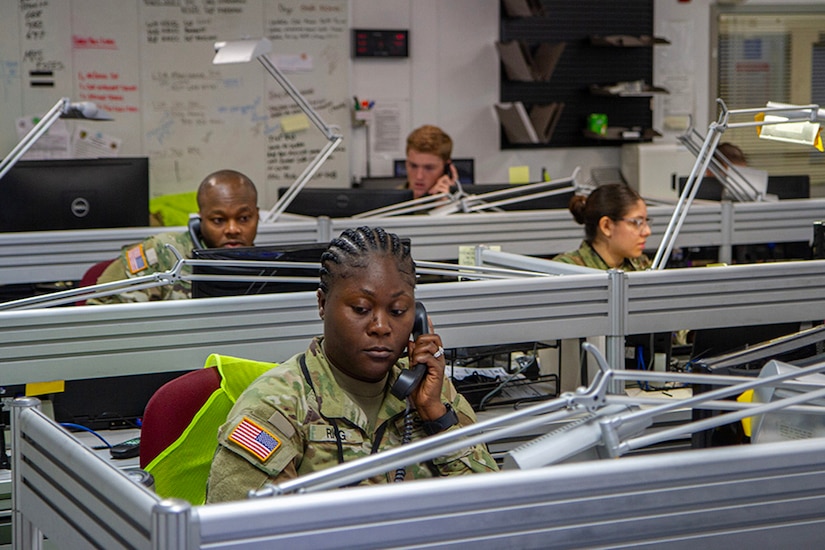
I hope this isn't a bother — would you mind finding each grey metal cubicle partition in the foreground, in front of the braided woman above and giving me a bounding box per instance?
[13,399,825,550]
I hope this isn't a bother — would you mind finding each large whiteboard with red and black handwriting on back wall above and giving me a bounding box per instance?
[0,0,351,208]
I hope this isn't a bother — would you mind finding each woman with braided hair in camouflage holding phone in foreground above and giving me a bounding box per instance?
[206,227,498,503]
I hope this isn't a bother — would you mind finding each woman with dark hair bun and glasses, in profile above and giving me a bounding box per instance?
[553,183,651,271]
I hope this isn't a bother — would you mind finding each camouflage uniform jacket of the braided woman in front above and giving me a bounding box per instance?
[206,337,498,502]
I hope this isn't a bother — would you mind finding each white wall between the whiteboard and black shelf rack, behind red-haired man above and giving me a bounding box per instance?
[350,0,620,182]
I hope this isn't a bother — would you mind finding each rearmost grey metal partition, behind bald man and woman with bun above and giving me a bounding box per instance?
[0,199,825,285]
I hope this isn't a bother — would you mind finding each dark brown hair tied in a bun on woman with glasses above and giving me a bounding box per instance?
[568,183,644,243]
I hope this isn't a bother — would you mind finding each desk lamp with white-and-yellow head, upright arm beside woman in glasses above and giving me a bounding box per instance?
[650,98,825,269]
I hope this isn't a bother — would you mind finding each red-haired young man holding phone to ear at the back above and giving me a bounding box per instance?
[406,125,458,199]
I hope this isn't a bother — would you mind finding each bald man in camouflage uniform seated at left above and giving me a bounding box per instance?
[87,170,258,304]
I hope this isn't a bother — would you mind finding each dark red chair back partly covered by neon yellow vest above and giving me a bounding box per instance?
[140,367,221,468]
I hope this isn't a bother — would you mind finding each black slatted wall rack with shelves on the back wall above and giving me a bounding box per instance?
[491,0,667,149]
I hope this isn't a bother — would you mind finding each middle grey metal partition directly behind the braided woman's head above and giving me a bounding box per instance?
[0,260,825,384]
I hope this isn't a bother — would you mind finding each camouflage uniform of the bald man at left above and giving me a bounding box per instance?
[86,231,194,304]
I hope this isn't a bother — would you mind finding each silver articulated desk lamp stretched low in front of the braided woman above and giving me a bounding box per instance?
[245,343,825,498]
